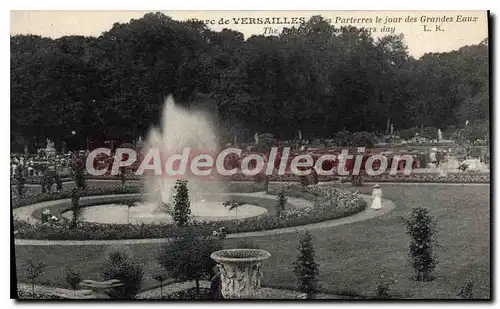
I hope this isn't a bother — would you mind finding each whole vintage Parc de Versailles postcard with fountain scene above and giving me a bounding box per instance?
[10,11,492,301]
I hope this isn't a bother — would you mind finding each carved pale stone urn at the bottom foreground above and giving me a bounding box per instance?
[210,249,271,299]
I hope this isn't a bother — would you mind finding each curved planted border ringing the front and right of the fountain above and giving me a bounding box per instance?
[14,184,366,240]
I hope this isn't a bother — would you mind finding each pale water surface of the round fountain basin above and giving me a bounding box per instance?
[62,201,267,224]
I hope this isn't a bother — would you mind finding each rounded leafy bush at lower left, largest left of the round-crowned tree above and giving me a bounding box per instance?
[100,245,144,299]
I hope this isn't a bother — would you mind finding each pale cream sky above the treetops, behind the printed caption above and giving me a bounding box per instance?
[10,11,488,58]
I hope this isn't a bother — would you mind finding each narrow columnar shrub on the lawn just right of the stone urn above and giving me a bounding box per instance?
[293,231,319,299]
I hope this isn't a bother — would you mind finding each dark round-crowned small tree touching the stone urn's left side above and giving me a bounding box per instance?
[158,227,222,295]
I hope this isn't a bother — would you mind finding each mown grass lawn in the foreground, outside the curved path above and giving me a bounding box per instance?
[16,184,490,298]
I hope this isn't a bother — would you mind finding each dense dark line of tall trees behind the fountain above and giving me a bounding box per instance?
[11,13,489,149]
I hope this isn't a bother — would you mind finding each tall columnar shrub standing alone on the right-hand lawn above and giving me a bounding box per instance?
[403,207,438,281]
